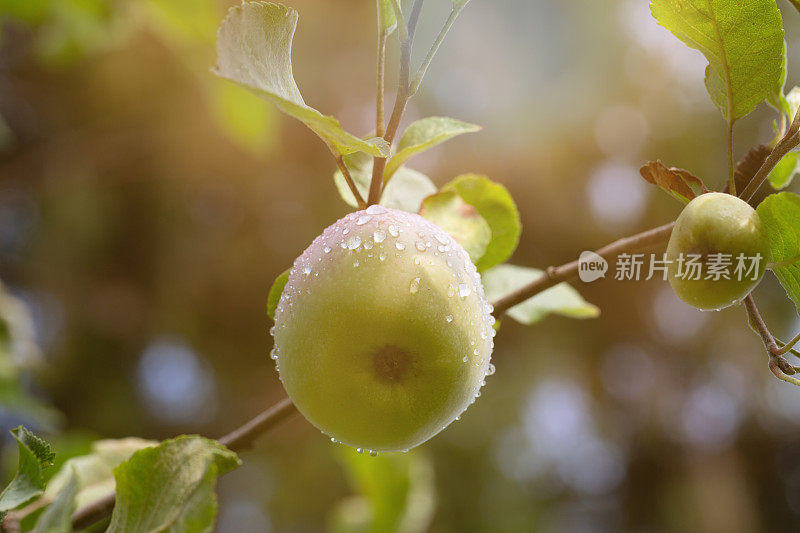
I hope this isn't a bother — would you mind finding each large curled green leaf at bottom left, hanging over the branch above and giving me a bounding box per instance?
[107,435,240,533]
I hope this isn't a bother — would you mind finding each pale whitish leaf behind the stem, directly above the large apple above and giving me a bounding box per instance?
[333,153,436,213]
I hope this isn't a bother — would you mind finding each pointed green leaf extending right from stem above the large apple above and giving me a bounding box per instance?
[383,117,481,182]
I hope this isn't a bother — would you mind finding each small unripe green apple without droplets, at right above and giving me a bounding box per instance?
[667,192,772,311]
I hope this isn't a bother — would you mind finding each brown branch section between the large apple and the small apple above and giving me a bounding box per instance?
[494,222,675,317]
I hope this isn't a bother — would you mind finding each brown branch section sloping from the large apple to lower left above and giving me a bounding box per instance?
[72,398,297,530]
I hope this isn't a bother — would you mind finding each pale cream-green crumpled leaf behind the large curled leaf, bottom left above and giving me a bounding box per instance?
[44,438,158,507]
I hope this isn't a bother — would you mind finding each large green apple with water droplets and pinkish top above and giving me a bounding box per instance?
[272,206,494,451]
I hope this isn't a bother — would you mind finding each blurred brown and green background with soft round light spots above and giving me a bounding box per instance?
[0,0,800,533]
